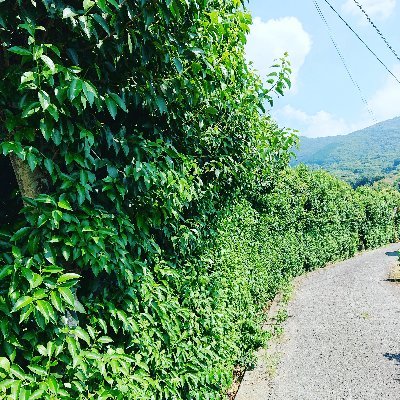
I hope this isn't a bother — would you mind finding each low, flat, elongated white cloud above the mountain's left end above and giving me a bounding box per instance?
[274,105,370,137]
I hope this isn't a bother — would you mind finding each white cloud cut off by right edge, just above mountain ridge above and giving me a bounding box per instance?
[368,65,400,121]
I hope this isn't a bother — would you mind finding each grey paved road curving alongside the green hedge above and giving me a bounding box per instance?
[236,244,400,400]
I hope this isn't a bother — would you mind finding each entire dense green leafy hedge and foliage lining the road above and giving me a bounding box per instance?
[0,0,399,400]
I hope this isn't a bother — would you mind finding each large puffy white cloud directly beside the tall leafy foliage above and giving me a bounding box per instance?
[246,17,312,88]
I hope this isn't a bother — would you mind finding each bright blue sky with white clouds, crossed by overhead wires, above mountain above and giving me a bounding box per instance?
[246,0,400,137]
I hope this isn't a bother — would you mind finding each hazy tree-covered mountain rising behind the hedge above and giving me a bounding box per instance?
[292,117,400,186]
